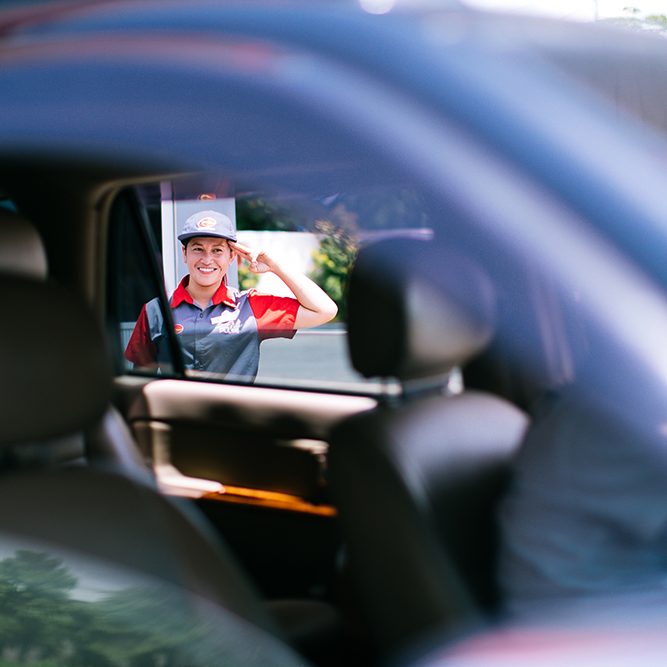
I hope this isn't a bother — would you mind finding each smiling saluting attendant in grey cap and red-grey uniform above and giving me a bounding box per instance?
[125,210,337,381]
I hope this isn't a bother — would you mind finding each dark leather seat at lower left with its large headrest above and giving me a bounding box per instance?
[0,272,310,665]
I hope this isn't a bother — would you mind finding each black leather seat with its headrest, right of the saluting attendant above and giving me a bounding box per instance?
[329,238,527,656]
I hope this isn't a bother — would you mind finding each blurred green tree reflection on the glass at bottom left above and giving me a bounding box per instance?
[0,550,280,667]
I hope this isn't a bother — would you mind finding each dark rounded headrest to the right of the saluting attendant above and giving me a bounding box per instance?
[348,238,495,382]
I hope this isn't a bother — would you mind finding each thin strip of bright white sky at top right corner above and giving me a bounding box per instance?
[464,0,667,21]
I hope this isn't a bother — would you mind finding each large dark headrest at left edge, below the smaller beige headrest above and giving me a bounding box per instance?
[0,274,112,445]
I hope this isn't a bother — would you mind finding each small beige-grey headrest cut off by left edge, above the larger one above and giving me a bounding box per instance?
[0,207,47,280]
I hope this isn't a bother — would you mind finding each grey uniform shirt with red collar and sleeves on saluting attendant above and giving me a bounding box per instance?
[125,276,299,378]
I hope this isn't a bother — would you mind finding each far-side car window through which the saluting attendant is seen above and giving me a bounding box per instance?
[117,180,432,392]
